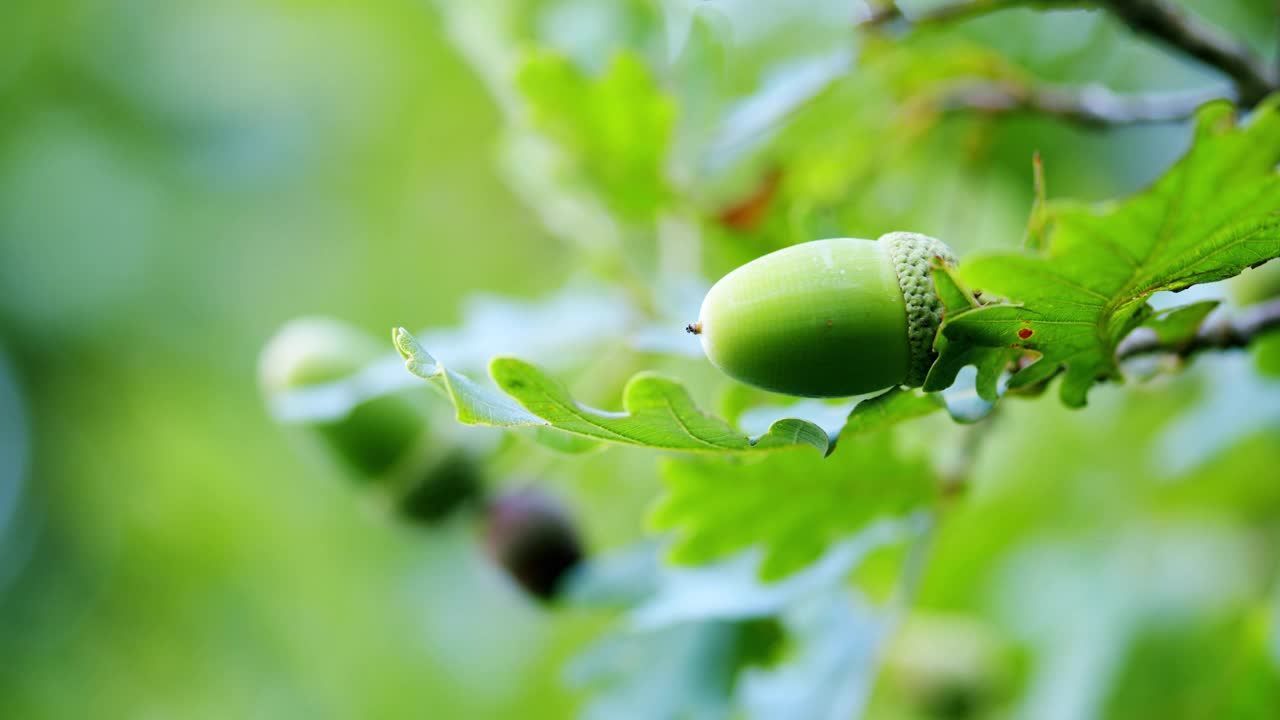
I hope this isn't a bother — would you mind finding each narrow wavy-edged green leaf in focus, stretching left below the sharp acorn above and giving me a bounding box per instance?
[393,328,831,457]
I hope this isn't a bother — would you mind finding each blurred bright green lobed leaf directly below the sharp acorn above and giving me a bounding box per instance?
[650,432,936,579]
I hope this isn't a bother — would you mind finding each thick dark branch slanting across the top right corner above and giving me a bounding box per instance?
[1097,0,1276,108]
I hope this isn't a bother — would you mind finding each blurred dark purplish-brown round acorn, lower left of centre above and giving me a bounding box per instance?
[485,487,585,601]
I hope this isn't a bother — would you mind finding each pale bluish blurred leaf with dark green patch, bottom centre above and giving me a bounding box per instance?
[570,521,920,720]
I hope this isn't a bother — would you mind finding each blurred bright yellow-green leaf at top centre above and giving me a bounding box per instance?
[517,53,675,219]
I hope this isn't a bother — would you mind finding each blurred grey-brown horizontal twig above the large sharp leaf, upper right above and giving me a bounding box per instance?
[938,81,1222,129]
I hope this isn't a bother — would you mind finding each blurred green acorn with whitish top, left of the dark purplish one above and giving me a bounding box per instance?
[259,318,484,524]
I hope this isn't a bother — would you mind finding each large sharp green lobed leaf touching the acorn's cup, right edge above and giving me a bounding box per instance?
[925,100,1280,407]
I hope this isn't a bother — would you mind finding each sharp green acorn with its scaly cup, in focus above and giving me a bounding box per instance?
[686,232,956,397]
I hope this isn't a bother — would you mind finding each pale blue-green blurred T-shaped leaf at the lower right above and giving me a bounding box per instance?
[996,524,1261,720]
